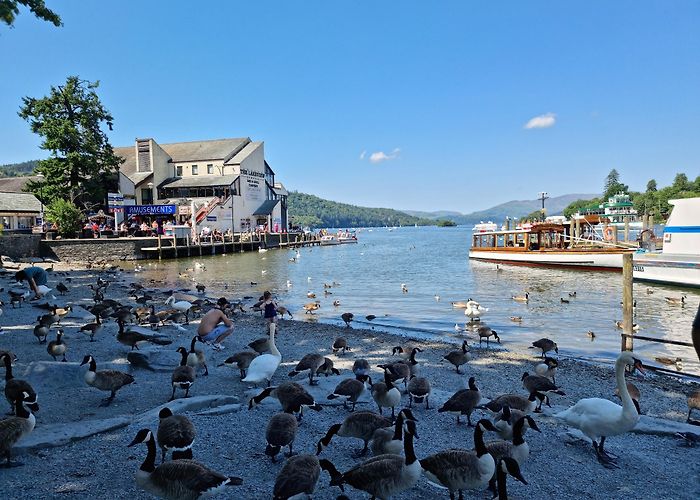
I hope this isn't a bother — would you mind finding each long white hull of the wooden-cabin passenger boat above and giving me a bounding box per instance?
[469,250,625,272]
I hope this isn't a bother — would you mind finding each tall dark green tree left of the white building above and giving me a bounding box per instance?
[19,76,123,208]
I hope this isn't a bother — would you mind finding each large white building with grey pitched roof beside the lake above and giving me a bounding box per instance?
[114,138,287,232]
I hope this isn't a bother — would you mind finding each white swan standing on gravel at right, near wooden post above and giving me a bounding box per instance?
[554,351,643,468]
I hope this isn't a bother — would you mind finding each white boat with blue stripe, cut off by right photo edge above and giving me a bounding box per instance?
[633,198,700,287]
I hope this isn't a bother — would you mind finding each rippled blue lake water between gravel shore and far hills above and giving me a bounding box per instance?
[133,227,700,373]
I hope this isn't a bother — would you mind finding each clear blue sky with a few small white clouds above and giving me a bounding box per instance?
[0,0,700,212]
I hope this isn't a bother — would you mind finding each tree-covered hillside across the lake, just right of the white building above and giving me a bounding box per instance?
[288,191,435,228]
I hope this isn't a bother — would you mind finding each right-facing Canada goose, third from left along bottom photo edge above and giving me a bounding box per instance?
[321,420,421,500]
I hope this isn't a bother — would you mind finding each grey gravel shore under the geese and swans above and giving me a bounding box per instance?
[0,267,700,500]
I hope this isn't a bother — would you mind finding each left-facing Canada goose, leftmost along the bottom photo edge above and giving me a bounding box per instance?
[129,429,243,499]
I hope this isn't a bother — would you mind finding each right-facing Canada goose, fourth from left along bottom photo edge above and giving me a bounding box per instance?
[420,419,496,500]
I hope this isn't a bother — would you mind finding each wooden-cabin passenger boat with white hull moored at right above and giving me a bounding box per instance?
[469,222,634,271]
